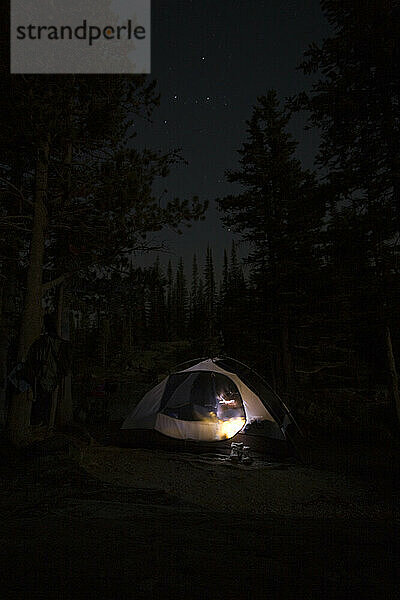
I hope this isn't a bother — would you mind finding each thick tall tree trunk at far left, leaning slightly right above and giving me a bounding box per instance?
[7,138,50,445]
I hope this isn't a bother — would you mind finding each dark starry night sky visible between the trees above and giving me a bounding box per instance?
[138,0,329,266]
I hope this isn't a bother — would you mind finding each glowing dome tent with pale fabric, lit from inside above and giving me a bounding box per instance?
[122,358,297,442]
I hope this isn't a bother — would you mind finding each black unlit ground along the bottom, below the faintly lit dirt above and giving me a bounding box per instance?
[0,436,399,600]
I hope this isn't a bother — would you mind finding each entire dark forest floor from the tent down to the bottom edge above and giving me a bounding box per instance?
[0,438,399,600]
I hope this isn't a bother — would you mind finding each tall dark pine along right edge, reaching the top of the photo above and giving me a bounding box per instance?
[292,0,400,419]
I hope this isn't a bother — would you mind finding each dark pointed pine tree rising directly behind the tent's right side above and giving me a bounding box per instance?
[219,91,324,389]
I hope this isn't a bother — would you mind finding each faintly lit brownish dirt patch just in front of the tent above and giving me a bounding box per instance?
[80,447,395,518]
